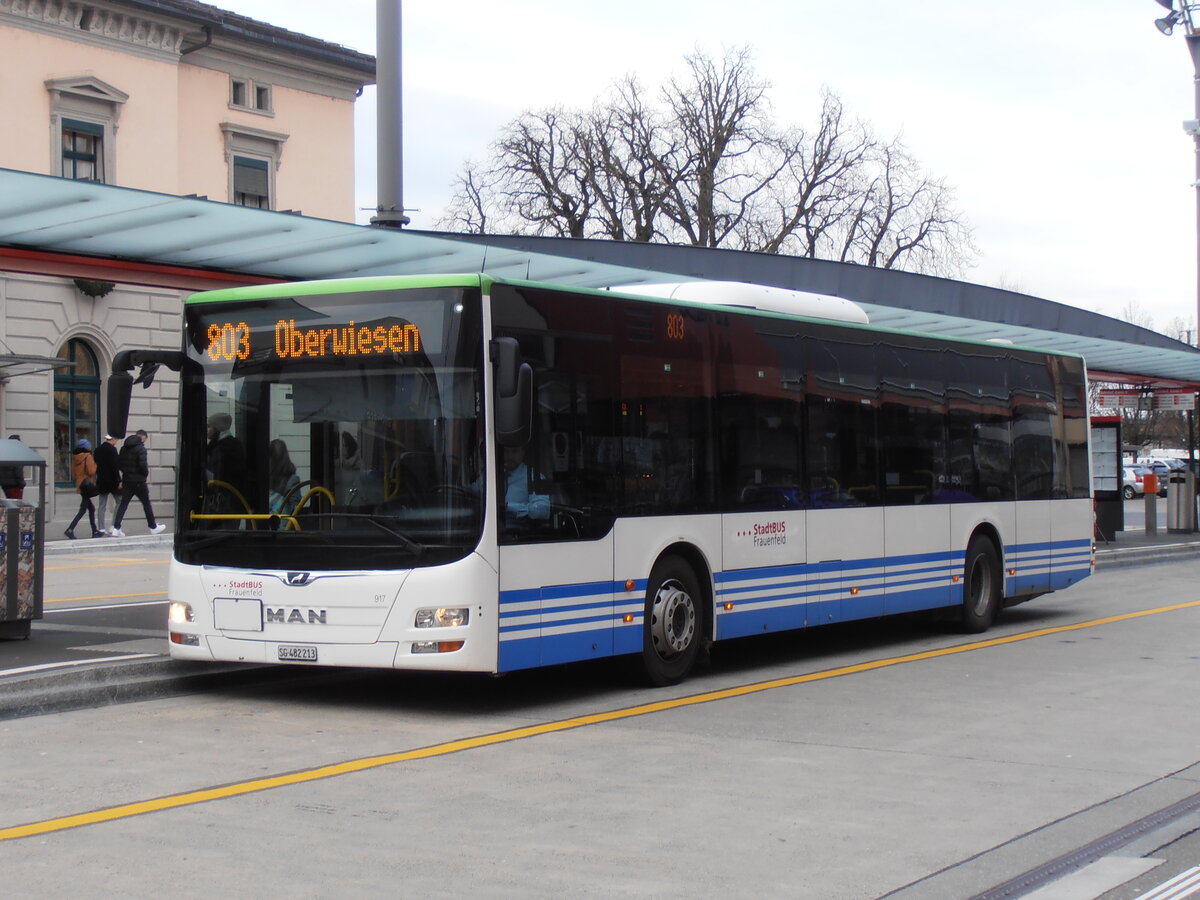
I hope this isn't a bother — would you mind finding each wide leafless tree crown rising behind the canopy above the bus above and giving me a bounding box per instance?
[439,48,977,275]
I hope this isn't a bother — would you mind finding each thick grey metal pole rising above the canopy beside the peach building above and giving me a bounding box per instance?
[371,0,410,229]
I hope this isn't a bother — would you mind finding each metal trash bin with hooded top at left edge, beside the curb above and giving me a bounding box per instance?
[0,439,46,637]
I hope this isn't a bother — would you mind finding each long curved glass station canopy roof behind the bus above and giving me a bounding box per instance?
[7,169,1200,390]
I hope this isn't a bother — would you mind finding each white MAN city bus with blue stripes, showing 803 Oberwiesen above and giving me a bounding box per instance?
[109,275,1094,685]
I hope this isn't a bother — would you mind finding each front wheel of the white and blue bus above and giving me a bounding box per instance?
[642,556,704,688]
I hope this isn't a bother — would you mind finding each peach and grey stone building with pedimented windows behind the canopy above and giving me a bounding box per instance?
[0,0,374,536]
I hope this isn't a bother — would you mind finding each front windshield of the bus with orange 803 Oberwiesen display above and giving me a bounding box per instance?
[178,287,485,570]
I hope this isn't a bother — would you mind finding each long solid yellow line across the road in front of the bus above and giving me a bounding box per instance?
[0,600,1200,841]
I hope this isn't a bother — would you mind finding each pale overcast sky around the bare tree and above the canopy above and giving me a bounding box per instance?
[225,0,1198,338]
